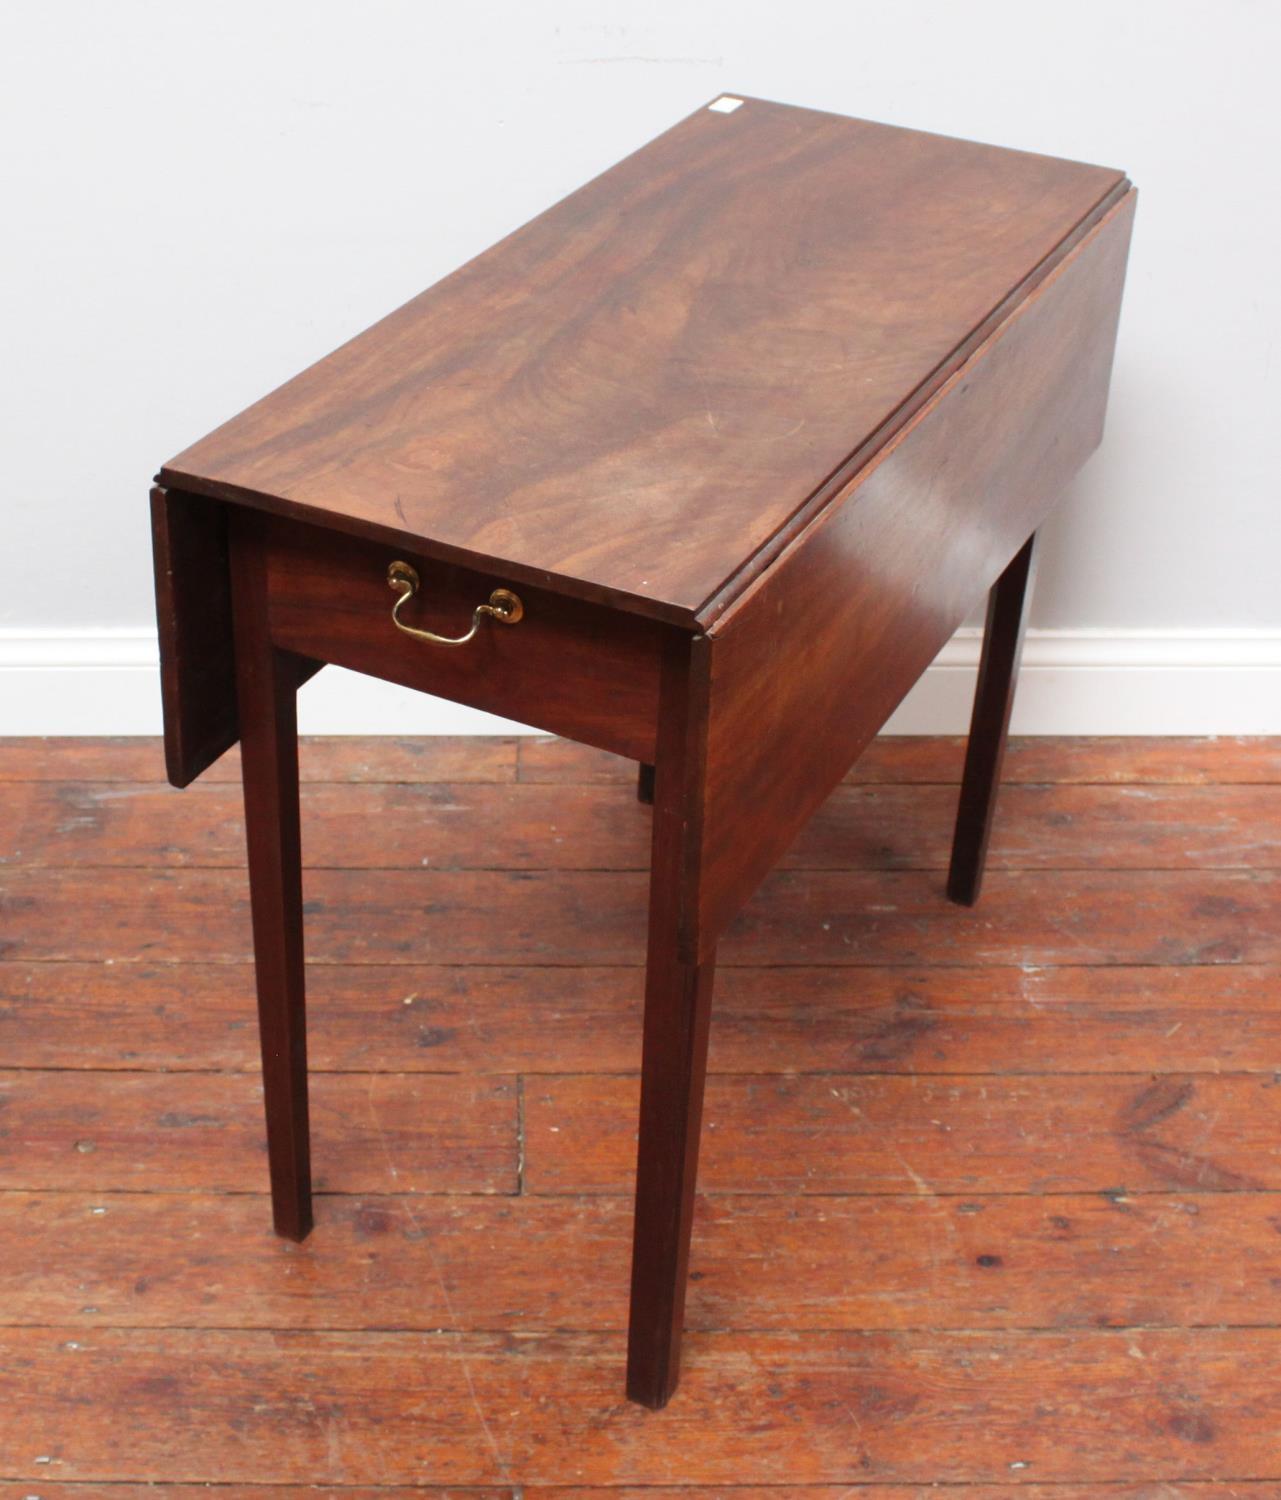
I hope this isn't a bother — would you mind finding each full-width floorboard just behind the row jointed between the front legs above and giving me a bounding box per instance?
[0,962,1281,1074]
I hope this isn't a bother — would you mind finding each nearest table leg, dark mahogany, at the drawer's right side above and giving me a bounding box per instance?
[627,645,714,1407]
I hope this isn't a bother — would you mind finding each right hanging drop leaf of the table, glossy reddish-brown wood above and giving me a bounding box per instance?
[698,192,1136,944]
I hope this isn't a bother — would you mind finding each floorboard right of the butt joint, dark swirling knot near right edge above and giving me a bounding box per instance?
[525,1074,1281,1194]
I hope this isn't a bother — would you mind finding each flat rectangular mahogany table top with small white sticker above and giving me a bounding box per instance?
[161,99,1125,624]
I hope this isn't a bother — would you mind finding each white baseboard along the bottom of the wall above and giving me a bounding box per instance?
[0,629,1281,735]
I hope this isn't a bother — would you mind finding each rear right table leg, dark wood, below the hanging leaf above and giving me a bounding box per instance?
[948,533,1037,906]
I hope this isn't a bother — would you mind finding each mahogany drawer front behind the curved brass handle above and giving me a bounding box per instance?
[252,516,671,761]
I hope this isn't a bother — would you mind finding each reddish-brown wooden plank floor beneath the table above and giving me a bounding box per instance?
[0,740,1281,1500]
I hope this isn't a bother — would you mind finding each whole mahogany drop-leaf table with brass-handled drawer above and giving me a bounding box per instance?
[152,98,1136,1407]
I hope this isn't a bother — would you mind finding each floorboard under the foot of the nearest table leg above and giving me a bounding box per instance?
[0,1325,1281,1485]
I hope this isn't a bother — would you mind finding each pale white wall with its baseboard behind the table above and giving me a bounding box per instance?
[0,0,1281,732]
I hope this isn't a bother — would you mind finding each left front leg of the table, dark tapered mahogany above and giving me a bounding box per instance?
[231,527,312,1239]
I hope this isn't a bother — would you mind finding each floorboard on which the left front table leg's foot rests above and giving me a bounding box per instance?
[10,1190,1281,1332]
